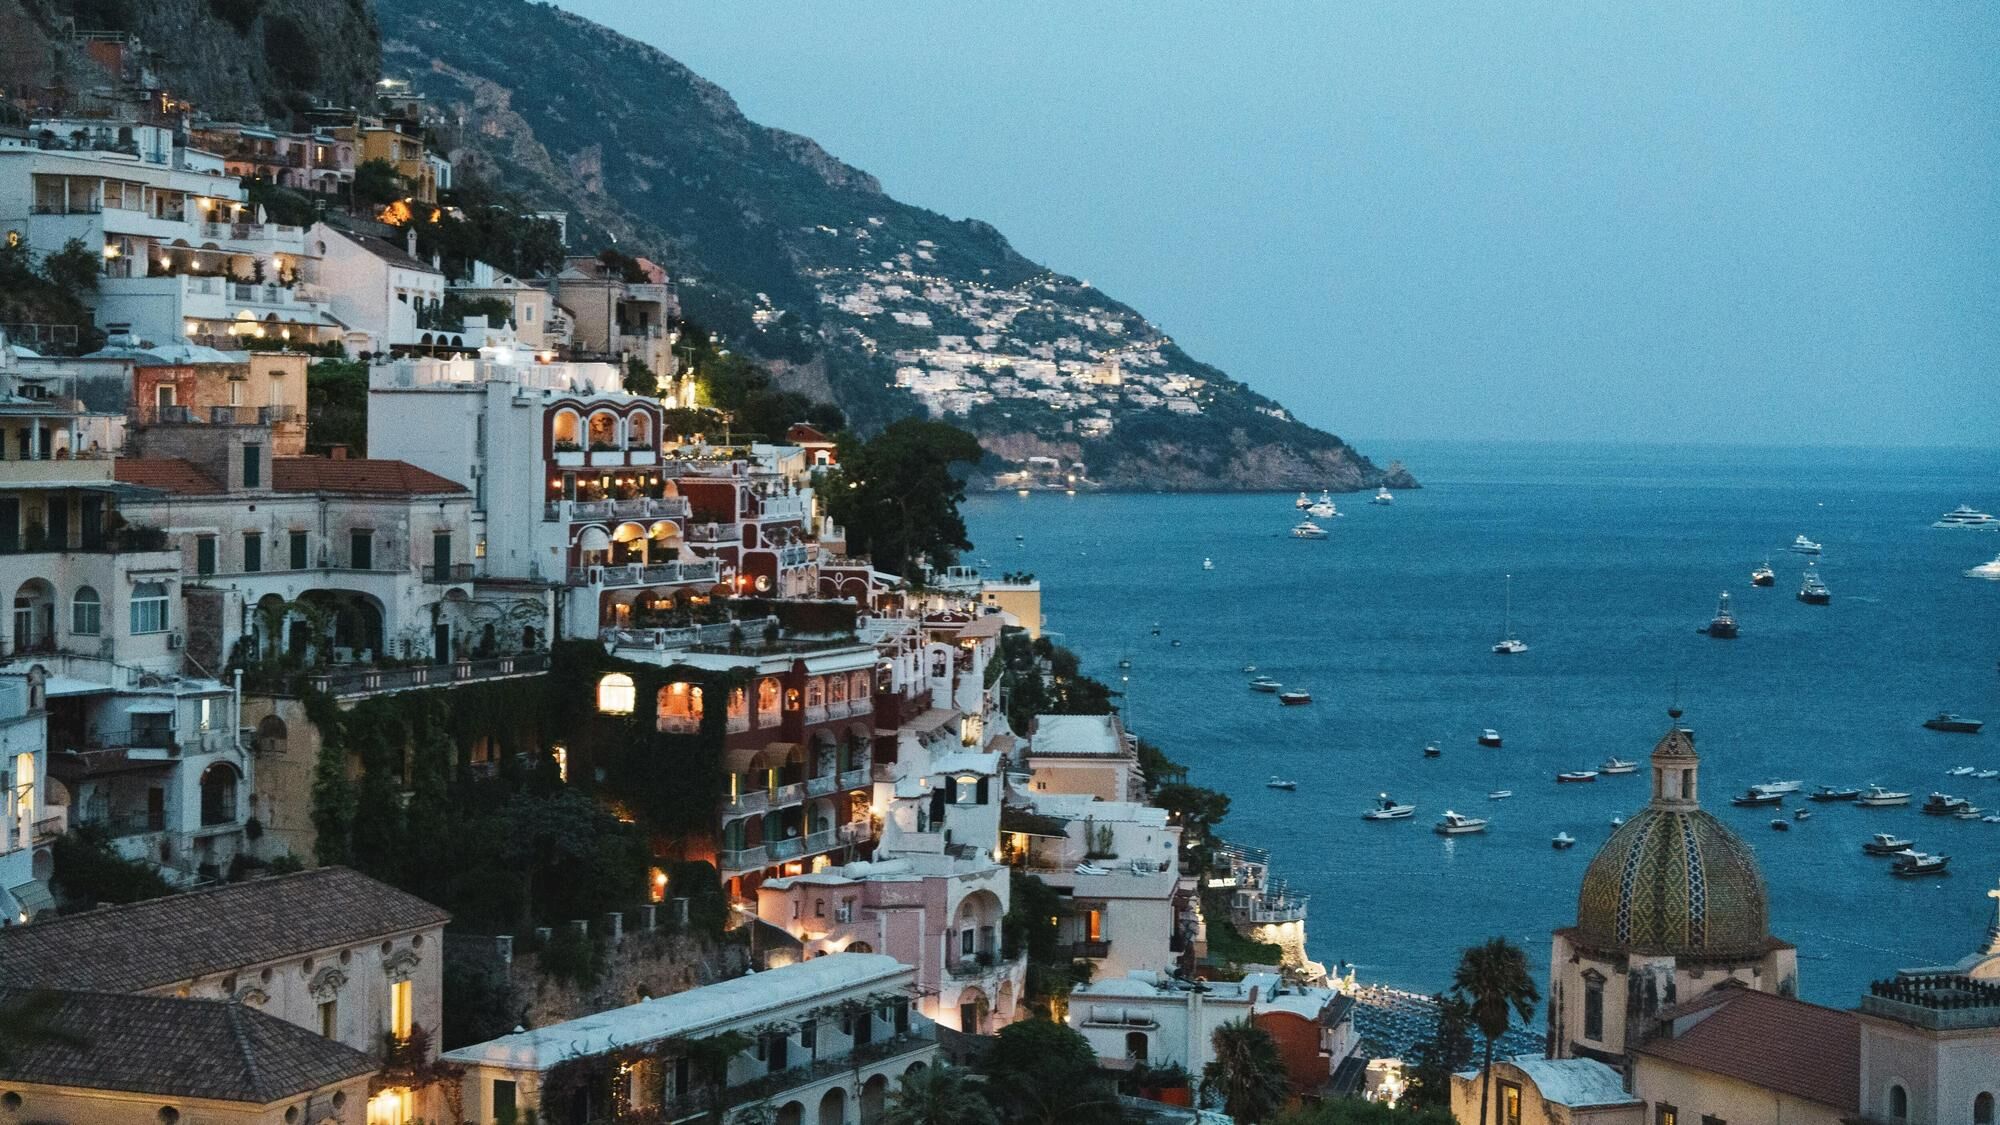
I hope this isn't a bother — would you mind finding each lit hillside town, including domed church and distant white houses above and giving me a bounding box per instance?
[0,19,2000,1125]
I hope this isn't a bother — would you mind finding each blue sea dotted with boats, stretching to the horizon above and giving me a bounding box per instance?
[964,442,2000,1007]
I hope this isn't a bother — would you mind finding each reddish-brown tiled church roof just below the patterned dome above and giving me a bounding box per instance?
[1636,976,1862,1113]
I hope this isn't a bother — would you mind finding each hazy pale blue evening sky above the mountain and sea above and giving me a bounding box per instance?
[560,0,2000,448]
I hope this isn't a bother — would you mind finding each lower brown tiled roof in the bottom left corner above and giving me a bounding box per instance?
[0,989,376,1111]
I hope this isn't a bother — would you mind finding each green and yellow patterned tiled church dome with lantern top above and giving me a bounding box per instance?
[1576,711,1770,957]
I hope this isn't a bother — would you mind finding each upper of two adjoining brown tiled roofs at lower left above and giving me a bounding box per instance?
[0,867,450,993]
